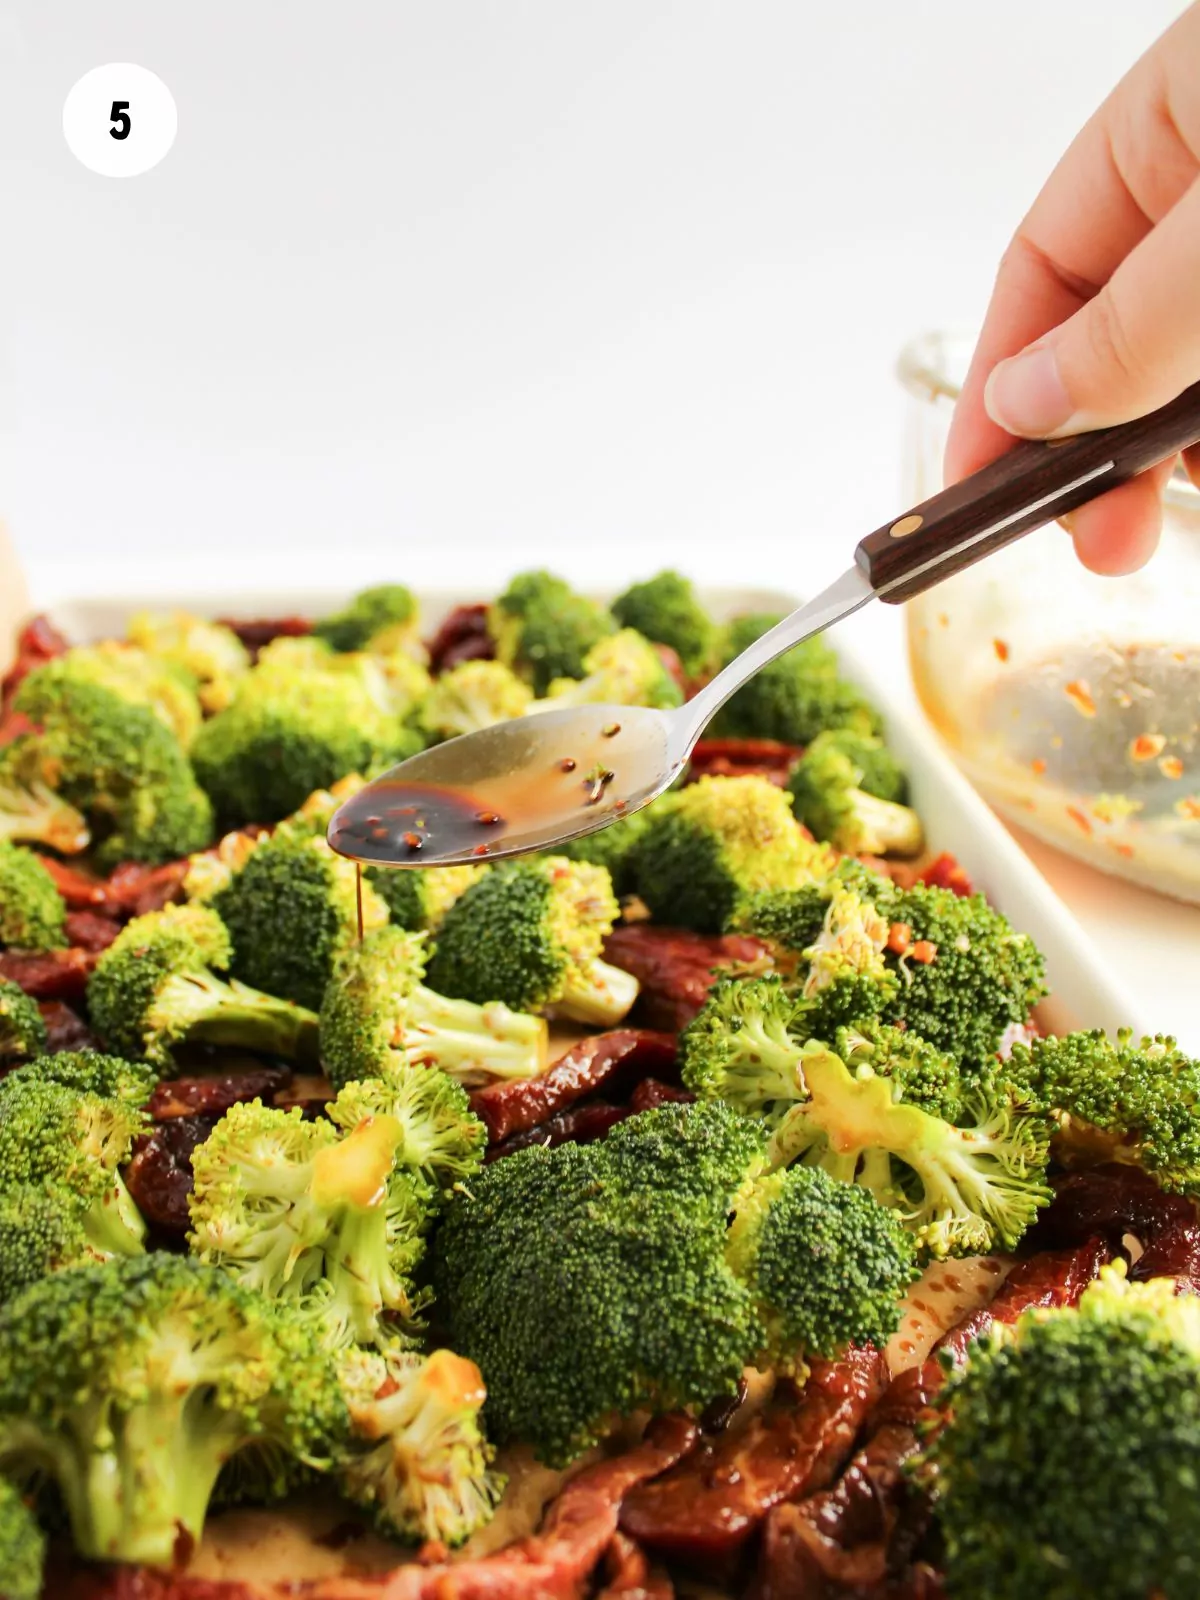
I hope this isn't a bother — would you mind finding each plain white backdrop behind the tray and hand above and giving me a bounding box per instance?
[0,0,1195,1026]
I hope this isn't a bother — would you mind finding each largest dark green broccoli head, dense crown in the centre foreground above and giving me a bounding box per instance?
[434,1106,762,1464]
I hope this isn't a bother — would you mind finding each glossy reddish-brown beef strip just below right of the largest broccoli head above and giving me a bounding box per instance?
[621,1349,888,1573]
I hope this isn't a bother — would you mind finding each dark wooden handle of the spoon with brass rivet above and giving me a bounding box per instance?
[854,384,1200,605]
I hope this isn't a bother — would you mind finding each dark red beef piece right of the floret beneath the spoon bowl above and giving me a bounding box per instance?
[605,922,771,1034]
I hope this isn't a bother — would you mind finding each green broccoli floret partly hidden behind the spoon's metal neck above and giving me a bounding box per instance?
[712,616,880,744]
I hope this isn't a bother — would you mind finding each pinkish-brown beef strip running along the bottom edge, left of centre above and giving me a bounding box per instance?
[296,1414,699,1600]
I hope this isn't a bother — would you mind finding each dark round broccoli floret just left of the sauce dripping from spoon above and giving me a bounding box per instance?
[213,829,387,1010]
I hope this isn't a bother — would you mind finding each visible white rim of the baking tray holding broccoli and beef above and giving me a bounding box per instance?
[40,587,1152,1032]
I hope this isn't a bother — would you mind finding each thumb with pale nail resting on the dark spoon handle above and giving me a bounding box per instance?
[984,179,1200,438]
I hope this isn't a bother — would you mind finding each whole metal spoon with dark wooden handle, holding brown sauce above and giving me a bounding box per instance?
[328,384,1200,867]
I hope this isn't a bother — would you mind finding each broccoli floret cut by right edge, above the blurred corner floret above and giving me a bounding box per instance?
[1005,1029,1200,1195]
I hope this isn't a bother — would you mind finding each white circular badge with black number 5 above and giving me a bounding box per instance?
[62,61,179,178]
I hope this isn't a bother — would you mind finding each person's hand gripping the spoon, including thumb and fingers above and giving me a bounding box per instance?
[946,3,1200,573]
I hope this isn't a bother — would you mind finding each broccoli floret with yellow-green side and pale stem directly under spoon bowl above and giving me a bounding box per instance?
[429,856,638,1027]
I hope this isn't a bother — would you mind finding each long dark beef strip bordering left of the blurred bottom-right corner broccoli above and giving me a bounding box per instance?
[754,1238,1112,1600]
